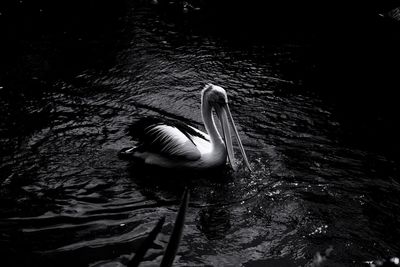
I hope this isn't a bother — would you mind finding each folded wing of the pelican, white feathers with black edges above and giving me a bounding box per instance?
[129,118,208,160]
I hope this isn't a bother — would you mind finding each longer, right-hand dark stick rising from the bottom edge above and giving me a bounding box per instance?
[160,188,190,267]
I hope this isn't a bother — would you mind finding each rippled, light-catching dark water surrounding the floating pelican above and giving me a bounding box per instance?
[0,2,400,266]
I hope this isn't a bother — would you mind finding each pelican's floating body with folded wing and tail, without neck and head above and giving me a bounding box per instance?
[125,117,227,169]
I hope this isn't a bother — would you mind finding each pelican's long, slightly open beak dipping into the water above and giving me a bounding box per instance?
[216,104,251,171]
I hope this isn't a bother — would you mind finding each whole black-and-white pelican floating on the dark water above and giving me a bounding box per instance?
[119,84,251,171]
